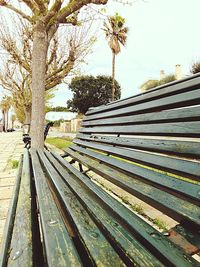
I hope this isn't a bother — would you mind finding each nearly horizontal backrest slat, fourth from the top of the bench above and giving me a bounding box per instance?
[79,121,200,137]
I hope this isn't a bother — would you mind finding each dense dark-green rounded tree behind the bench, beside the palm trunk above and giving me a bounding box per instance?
[67,75,121,114]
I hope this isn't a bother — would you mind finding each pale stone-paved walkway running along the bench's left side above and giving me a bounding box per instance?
[0,132,23,249]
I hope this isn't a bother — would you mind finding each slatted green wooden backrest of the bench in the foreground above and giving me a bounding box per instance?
[65,75,200,251]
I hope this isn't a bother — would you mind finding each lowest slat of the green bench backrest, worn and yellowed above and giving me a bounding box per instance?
[63,149,200,229]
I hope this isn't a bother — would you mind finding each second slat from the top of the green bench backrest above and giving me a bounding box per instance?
[84,89,200,121]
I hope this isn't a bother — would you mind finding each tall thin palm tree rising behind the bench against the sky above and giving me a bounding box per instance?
[103,13,128,101]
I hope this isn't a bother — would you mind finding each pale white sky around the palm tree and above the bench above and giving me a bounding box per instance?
[0,0,200,106]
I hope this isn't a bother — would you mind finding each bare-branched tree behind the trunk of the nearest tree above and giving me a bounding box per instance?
[0,13,94,126]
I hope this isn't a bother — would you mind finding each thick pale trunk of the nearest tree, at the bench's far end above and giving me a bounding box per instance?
[31,21,48,149]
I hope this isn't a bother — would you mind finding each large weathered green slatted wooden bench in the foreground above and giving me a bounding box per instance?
[0,75,200,267]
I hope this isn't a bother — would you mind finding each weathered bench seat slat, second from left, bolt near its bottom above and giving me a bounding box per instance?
[7,151,33,267]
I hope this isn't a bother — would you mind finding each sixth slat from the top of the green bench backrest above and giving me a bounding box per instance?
[74,139,200,179]
